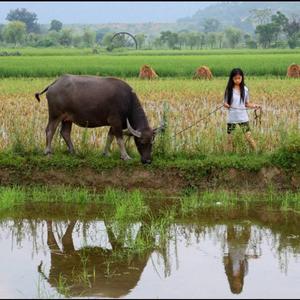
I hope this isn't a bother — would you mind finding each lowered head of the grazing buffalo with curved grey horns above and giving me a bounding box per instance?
[127,119,165,164]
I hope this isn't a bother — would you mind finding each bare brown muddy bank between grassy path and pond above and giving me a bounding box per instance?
[0,166,300,194]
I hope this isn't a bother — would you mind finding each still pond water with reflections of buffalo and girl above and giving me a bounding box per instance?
[0,203,300,298]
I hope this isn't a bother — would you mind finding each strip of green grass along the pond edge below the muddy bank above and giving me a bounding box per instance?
[0,186,300,220]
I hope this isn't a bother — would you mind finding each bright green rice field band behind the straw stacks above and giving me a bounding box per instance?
[0,48,300,78]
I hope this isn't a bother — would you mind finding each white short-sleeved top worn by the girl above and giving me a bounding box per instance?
[224,86,249,123]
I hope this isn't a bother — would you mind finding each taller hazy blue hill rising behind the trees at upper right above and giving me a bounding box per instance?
[177,1,300,32]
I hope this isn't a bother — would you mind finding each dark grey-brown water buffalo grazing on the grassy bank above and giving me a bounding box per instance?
[35,75,163,163]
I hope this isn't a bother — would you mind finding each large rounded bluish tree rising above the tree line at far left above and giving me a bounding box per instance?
[6,8,39,33]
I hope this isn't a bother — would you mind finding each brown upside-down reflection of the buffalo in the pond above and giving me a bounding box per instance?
[38,221,166,298]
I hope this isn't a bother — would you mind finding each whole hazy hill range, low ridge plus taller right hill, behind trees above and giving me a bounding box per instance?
[39,1,300,37]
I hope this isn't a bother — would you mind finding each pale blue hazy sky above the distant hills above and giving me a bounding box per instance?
[0,1,216,24]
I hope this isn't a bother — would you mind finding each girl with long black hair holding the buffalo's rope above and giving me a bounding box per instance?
[224,68,260,151]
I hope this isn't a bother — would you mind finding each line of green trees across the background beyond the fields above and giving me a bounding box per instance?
[0,8,300,49]
